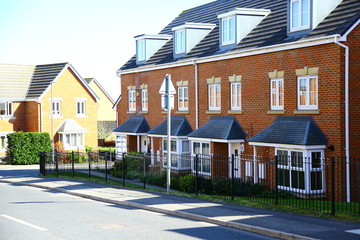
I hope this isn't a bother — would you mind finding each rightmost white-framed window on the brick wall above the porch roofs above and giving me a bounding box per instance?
[298,76,318,110]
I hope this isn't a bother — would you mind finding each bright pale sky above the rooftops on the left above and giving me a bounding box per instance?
[0,0,213,99]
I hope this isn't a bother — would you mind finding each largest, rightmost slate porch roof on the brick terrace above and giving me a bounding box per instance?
[249,116,328,145]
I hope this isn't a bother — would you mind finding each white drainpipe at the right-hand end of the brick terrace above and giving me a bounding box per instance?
[335,37,350,202]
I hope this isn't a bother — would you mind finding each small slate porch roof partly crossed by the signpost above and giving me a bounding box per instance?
[147,116,192,136]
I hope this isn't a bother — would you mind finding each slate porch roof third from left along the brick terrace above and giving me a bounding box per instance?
[188,116,245,140]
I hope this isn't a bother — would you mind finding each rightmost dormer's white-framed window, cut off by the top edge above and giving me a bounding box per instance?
[290,0,311,32]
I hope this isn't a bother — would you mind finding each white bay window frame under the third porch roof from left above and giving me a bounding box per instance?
[190,141,212,176]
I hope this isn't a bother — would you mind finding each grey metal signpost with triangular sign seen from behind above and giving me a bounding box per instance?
[159,74,176,195]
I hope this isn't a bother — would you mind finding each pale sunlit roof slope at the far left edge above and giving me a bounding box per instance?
[0,64,35,100]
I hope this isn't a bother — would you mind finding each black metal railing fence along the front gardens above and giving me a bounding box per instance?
[40,152,360,218]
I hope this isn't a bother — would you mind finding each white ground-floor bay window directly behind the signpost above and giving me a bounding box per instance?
[162,138,191,170]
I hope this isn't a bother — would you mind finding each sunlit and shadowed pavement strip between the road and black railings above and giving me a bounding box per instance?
[0,165,360,240]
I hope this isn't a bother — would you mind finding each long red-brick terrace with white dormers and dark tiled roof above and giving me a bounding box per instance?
[114,0,360,197]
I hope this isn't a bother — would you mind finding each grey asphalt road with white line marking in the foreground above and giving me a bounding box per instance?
[0,183,278,240]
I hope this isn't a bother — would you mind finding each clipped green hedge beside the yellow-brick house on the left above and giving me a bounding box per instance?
[7,132,51,165]
